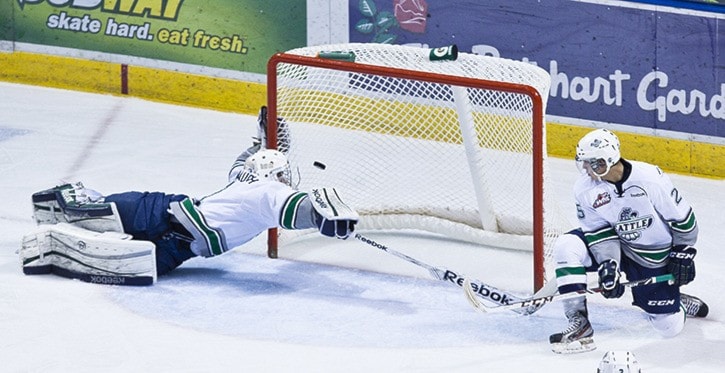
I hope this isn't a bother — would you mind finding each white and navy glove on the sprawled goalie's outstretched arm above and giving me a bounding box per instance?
[310,188,360,240]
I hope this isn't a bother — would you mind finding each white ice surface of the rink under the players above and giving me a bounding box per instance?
[0,83,725,373]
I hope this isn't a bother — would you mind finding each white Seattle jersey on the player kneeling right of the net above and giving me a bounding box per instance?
[574,160,698,268]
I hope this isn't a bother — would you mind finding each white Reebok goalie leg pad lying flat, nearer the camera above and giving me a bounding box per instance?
[19,223,157,285]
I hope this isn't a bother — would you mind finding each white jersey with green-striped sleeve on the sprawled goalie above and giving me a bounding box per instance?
[170,172,314,257]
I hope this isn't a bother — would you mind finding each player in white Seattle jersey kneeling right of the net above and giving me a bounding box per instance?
[549,129,708,353]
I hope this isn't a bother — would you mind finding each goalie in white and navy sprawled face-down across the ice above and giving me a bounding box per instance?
[20,149,358,285]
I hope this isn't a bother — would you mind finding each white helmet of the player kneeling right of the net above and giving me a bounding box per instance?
[575,129,621,177]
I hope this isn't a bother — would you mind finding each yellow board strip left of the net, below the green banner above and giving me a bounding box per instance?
[0,52,267,114]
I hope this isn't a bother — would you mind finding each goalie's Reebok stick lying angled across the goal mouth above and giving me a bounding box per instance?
[355,233,552,315]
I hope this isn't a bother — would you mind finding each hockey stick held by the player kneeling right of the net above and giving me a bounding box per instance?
[463,273,675,315]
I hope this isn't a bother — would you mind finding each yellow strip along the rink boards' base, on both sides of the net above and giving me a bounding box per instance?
[0,52,725,178]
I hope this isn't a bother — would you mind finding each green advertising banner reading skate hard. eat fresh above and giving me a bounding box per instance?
[5,0,307,73]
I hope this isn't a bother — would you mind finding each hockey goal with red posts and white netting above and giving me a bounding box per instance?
[267,44,563,289]
